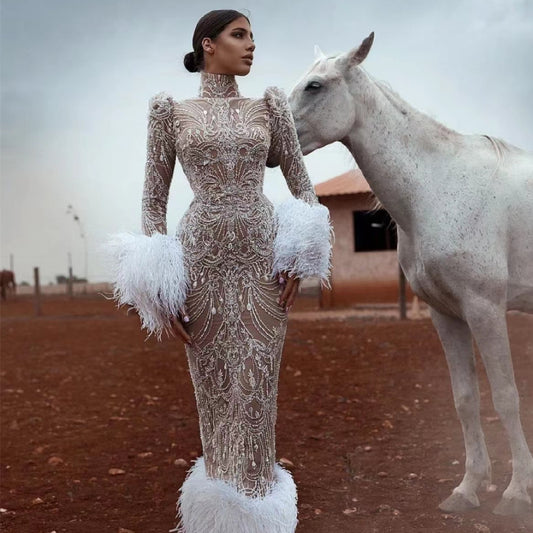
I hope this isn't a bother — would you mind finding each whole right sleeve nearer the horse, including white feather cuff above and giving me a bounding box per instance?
[264,87,334,288]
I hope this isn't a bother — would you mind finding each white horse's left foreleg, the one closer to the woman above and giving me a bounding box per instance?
[431,309,491,512]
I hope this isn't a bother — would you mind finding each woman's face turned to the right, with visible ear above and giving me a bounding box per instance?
[202,17,255,76]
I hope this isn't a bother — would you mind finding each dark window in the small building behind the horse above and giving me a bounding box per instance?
[353,209,398,252]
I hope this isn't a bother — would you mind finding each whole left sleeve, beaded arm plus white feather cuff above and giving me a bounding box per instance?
[105,92,189,340]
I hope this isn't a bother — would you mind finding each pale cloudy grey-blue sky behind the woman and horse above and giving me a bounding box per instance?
[0,0,533,283]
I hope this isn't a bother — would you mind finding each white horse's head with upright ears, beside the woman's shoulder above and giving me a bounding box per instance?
[289,32,374,155]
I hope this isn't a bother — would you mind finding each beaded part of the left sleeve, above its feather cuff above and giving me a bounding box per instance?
[141,92,176,235]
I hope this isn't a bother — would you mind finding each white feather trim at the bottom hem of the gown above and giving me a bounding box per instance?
[170,457,298,533]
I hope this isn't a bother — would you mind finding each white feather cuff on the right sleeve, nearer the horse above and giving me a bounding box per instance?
[272,197,334,288]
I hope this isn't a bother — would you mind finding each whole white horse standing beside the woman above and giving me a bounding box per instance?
[289,33,533,514]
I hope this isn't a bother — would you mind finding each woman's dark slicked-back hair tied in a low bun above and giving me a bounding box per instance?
[183,9,250,72]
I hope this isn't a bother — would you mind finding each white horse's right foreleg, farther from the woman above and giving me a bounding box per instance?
[468,301,533,515]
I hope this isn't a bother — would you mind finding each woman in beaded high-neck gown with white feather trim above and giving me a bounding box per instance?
[105,10,332,533]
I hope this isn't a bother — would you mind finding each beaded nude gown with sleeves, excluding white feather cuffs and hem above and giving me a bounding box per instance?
[142,72,317,496]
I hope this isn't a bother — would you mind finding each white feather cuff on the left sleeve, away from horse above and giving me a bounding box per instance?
[103,233,188,340]
